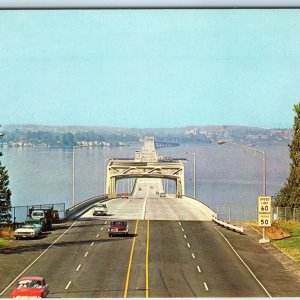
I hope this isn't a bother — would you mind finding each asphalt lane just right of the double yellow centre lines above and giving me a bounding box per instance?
[149,221,207,298]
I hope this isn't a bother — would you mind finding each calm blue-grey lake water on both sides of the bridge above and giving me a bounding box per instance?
[1,143,290,219]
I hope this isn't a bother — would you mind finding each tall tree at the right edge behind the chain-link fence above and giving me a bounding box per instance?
[275,103,300,207]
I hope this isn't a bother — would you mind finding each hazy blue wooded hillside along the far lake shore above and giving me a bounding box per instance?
[1,124,293,147]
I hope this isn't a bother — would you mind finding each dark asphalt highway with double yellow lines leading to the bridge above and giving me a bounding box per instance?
[0,199,300,298]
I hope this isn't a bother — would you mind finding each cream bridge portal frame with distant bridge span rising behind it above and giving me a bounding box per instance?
[106,137,185,198]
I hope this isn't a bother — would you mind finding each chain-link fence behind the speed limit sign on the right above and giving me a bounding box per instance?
[215,205,300,222]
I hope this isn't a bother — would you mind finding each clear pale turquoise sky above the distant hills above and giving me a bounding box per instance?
[0,9,300,128]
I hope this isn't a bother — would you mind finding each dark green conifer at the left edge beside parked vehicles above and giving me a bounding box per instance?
[0,126,11,224]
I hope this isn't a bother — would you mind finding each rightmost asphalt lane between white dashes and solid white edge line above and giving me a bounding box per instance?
[182,221,268,297]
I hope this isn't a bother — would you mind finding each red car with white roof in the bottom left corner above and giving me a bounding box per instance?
[9,276,50,298]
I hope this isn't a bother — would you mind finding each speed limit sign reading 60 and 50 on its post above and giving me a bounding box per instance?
[258,196,272,243]
